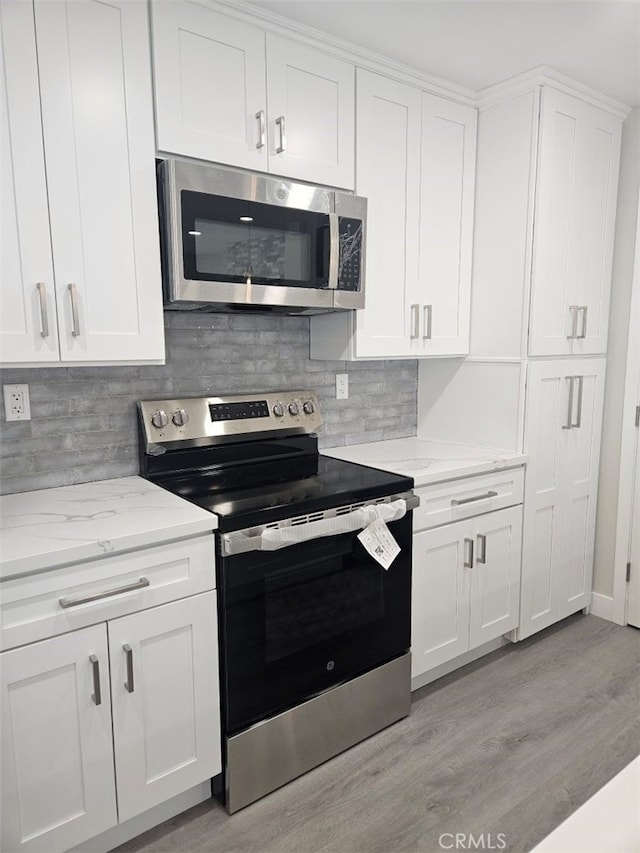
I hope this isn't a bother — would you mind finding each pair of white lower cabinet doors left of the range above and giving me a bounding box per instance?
[0,591,221,853]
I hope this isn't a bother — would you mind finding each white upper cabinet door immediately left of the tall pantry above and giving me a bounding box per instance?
[419,94,477,355]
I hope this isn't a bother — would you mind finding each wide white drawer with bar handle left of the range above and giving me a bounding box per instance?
[0,533,215,649]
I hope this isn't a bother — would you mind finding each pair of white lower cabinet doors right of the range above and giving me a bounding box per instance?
[411,505,522,678]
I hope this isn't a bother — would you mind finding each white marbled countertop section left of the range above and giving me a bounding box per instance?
[0,477,218,580]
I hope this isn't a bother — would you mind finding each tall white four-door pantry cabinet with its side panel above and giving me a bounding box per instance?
[418,69,626,639]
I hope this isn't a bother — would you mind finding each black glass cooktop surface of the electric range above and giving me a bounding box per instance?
[151,455,413,531]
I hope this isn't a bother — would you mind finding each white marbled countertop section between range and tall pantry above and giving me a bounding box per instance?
[322,437,528,487]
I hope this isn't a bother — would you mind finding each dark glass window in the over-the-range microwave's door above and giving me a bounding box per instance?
[181,190,329,288]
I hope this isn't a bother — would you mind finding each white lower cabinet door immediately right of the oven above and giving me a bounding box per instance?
[411,521,470,677]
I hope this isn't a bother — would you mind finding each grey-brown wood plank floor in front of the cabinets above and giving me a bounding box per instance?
[119,615,640,853]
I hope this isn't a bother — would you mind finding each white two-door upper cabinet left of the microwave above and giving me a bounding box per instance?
[2,0,164,363]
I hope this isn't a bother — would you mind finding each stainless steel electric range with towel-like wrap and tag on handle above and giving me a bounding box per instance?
[139,391,418,813]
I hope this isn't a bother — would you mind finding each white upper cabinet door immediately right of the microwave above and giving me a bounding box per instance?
[355,69,421,358]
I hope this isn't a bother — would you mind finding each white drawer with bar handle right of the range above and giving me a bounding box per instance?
[413,467,524,531]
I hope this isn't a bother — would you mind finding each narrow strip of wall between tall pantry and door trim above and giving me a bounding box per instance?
[593,107,640,596]
